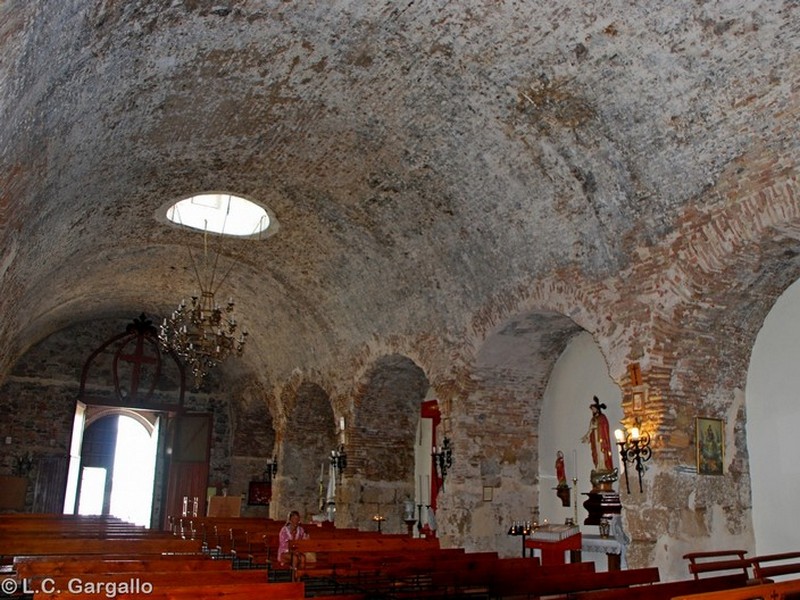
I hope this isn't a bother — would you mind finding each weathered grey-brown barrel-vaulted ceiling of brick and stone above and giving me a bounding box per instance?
[0,0,800,386]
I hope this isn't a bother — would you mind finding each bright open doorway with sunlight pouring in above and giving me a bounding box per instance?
[74,411,159,527]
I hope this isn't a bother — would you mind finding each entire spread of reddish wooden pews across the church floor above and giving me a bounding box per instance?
[6,515,800,600]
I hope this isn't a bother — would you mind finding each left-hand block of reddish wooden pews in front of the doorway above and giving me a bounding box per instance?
[0,515,364,600]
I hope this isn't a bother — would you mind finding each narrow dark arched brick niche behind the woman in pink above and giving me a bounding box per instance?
[270,381,336,519]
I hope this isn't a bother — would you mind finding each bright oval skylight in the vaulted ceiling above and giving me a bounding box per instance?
[166,193,271,237]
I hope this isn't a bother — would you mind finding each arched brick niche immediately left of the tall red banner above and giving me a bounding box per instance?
[337,354,430,533]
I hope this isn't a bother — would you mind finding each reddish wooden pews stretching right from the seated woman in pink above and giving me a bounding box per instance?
[291,537,659,599]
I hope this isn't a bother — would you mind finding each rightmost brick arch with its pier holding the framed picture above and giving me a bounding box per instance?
[564,164,800,572]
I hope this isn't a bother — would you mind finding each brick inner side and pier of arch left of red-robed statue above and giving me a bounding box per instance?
[437,309,588,555]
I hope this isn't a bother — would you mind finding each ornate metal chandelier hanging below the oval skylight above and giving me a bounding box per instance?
[158,227,247,389]
